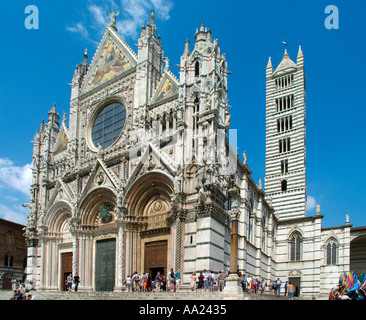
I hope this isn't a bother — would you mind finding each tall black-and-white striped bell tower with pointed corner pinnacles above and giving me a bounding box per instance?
[265,47,306,220]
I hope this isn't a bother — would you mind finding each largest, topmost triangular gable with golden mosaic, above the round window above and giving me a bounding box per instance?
[82,27,137,92]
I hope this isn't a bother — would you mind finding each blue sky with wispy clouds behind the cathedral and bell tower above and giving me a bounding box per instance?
[0,0,366,227]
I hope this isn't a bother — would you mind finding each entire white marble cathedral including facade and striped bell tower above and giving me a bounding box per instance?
[25,12,364,295]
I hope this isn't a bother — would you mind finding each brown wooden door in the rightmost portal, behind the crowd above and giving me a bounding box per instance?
[145,240,168,276]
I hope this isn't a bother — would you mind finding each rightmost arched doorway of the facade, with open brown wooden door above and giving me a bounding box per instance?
[126,172,174,277]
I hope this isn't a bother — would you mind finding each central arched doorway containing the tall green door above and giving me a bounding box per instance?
[77,187,118,291]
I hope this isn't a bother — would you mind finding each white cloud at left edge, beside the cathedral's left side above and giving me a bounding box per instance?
[0,158,32,196]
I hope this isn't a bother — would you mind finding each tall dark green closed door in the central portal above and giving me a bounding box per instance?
[95,239,116,291]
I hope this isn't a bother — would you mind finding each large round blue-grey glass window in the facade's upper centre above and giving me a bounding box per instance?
[91,102,126,149]
